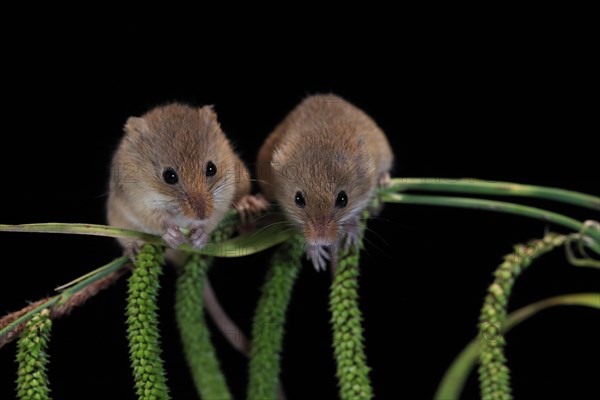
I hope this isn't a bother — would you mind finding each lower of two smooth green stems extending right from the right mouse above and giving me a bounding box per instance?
[382,193,600,254]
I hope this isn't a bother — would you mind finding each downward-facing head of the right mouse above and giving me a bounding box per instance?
[271,137,375,245]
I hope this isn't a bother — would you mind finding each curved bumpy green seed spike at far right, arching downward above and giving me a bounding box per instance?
[479,233,566,400]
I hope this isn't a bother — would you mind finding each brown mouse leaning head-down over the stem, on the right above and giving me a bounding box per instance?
[258,95,394,270]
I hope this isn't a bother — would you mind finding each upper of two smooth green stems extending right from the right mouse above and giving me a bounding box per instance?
[390,178,600,211]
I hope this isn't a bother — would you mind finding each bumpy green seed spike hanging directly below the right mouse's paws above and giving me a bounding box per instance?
[329,223,373,400]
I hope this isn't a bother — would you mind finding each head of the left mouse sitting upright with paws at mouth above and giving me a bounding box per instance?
[121,104,238,223]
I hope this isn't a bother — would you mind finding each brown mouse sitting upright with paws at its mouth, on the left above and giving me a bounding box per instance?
[107,103,250,250]
